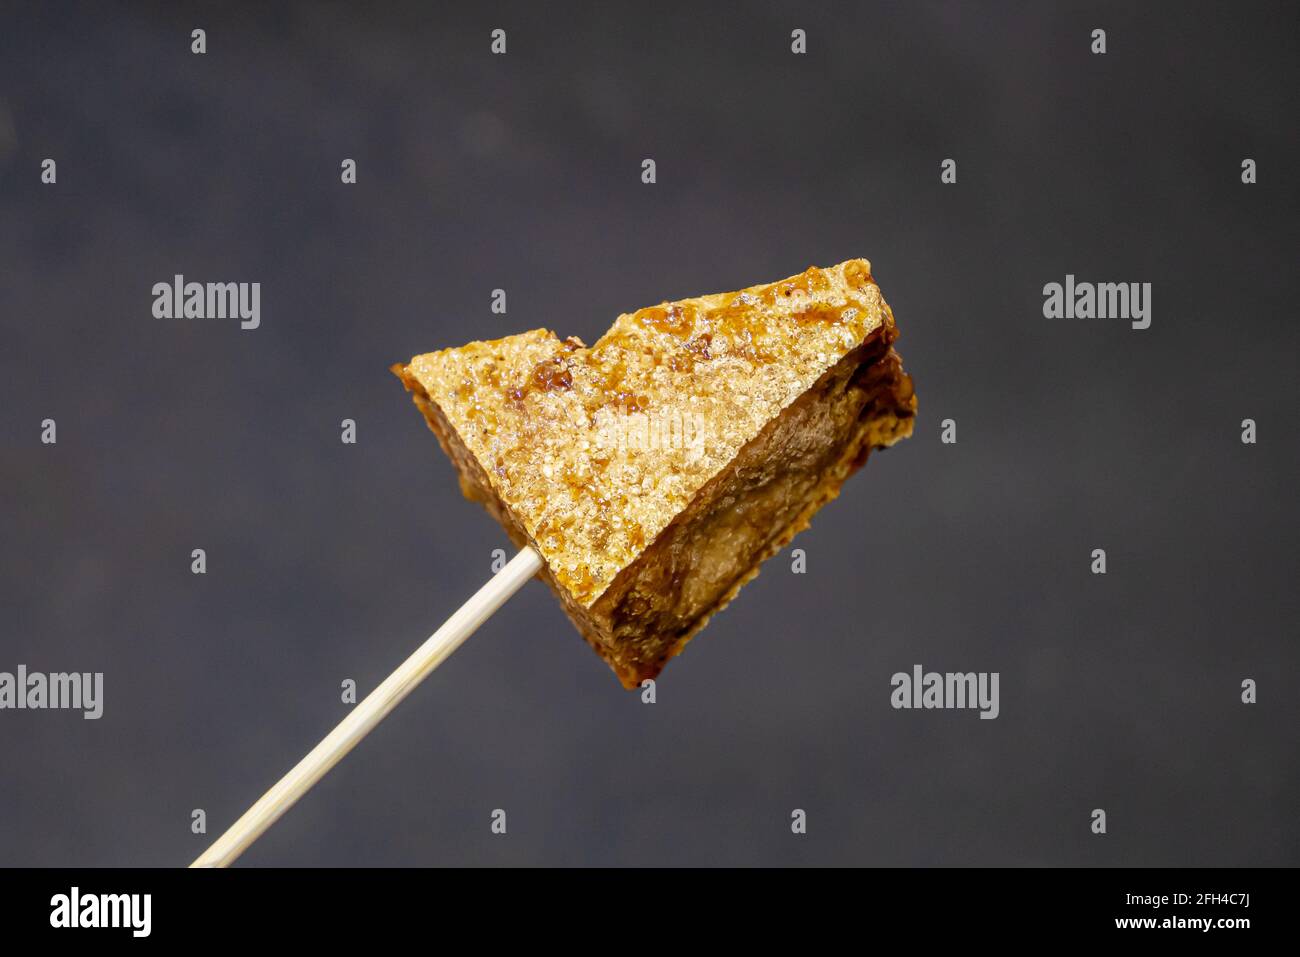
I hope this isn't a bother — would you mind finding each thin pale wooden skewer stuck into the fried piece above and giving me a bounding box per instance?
[190,547,542,867]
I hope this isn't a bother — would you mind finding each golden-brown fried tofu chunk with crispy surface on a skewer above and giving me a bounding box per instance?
[393,259,917,688]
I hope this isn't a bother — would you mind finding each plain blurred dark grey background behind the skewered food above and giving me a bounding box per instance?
[0,3,1300,865]
